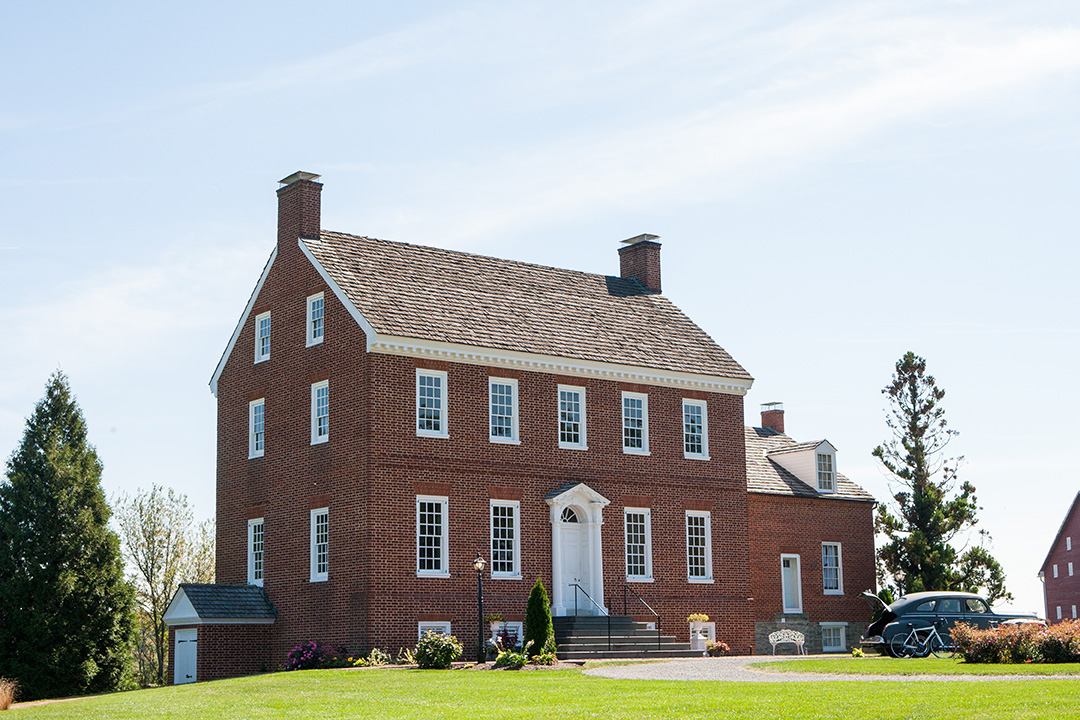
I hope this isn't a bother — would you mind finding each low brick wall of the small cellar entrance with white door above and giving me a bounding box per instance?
[167,625,274,684]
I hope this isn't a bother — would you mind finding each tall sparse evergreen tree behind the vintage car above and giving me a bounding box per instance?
[874,352,1012,602]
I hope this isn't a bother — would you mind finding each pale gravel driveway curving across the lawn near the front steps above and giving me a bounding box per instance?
[584,655,1080,682]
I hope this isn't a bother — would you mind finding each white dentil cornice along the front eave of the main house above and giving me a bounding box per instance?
[368,335,754,395]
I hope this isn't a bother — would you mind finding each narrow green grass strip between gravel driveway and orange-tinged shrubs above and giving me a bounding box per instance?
[754,656,1080,676]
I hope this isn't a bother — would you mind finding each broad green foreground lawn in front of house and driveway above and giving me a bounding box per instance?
[12,669,1080,720]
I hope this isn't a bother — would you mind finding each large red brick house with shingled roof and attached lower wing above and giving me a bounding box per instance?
[166,173,874,682]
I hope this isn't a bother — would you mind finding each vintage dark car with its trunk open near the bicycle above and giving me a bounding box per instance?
[863,590,1038,652]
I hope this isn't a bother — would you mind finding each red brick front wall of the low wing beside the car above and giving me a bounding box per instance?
[747,493,877,650]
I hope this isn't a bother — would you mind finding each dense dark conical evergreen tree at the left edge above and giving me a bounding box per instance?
[0,371,134,699]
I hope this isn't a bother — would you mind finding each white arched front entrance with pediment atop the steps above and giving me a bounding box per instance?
[545,483,611,615]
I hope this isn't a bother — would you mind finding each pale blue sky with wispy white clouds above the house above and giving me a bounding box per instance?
[0,0,1080,612]
